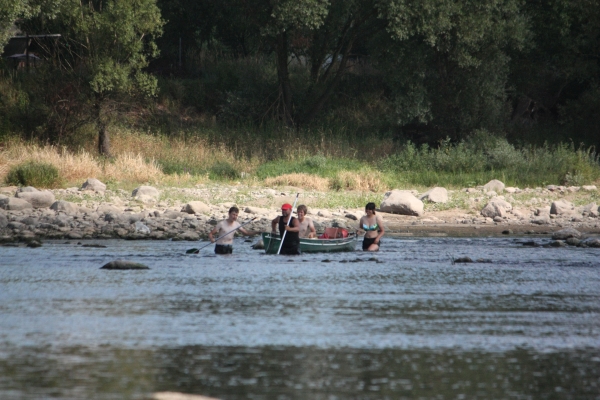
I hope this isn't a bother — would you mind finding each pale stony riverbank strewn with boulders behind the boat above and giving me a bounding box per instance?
[0,179,600,247]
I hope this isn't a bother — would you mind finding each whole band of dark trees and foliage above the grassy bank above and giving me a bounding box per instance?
[0,0,600,155]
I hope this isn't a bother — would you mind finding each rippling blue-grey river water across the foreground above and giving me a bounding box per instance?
[0,237,600,400]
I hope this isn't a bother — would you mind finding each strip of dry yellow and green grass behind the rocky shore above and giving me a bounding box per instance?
[0,125,600,193]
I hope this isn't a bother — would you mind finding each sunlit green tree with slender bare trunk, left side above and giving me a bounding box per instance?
[21,0,163,156]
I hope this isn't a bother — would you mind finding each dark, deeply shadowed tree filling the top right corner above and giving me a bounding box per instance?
[511,0,600,146]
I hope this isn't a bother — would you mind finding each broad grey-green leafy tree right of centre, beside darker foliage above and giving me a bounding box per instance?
[377,0,527,142]
